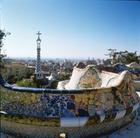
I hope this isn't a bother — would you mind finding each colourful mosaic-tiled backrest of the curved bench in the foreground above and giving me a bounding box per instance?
[0,75,138,117]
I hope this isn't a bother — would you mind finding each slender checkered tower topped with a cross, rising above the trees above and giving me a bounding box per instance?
[35,32,43,79]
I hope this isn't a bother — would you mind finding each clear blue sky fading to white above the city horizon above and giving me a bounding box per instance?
[0,0,140,58]
